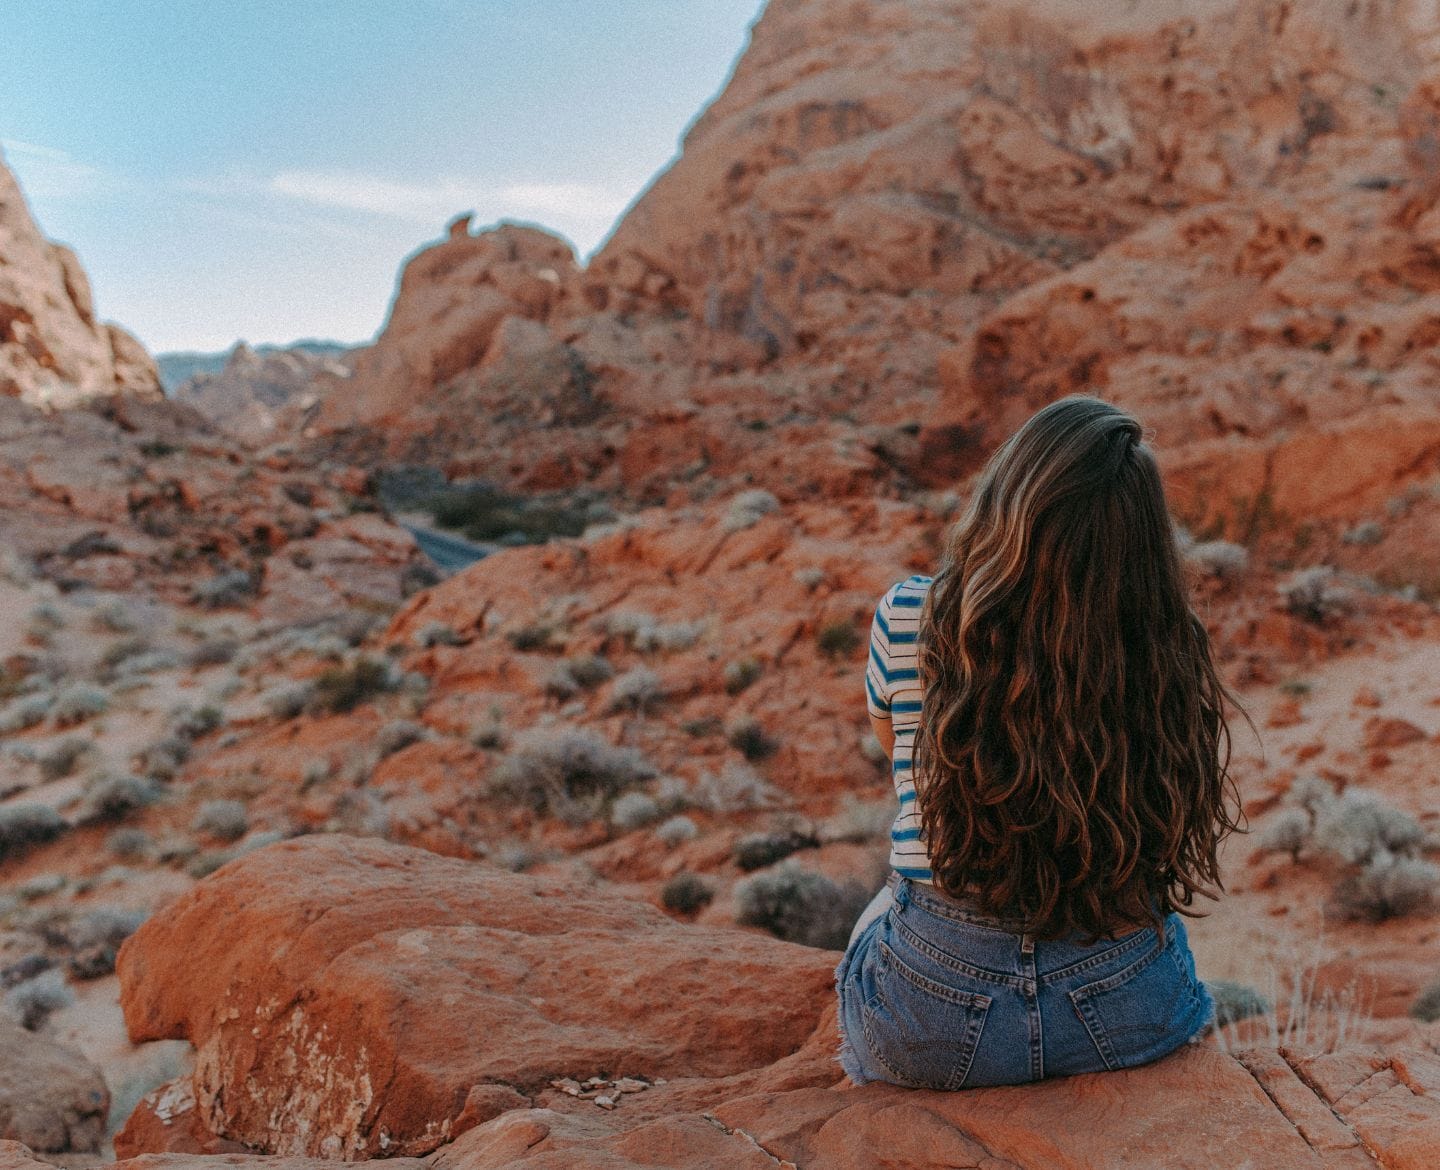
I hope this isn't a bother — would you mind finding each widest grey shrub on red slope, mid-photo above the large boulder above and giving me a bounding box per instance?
[490,728,655,823]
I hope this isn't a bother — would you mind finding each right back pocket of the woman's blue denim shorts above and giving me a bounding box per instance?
[1070,932,1207,1069]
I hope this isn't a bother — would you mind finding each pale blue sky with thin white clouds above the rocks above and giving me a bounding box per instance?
[0,0,762,353]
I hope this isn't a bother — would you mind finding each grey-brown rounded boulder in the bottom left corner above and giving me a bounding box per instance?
[0,1016,109,1158]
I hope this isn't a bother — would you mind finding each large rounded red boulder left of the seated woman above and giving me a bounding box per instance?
[118,839,834,1158]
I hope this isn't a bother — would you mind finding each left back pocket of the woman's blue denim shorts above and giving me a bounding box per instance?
[863,939,991,1089]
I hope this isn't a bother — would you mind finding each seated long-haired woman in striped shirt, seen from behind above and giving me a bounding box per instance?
[835,396,1238,1089]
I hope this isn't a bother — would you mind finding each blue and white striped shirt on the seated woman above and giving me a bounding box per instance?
[865,576,932,882]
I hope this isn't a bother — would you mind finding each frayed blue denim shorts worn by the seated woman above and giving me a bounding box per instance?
[835,875,1214,1089]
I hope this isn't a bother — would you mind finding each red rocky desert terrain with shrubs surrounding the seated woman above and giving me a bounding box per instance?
[0,0,1440,1170]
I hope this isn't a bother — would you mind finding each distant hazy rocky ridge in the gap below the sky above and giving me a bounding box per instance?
[174,341,353,447]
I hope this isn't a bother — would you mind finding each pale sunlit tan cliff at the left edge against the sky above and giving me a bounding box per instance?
[0,150,160,406]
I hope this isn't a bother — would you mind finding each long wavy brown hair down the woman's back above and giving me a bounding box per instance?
[914,395,1253,939]
